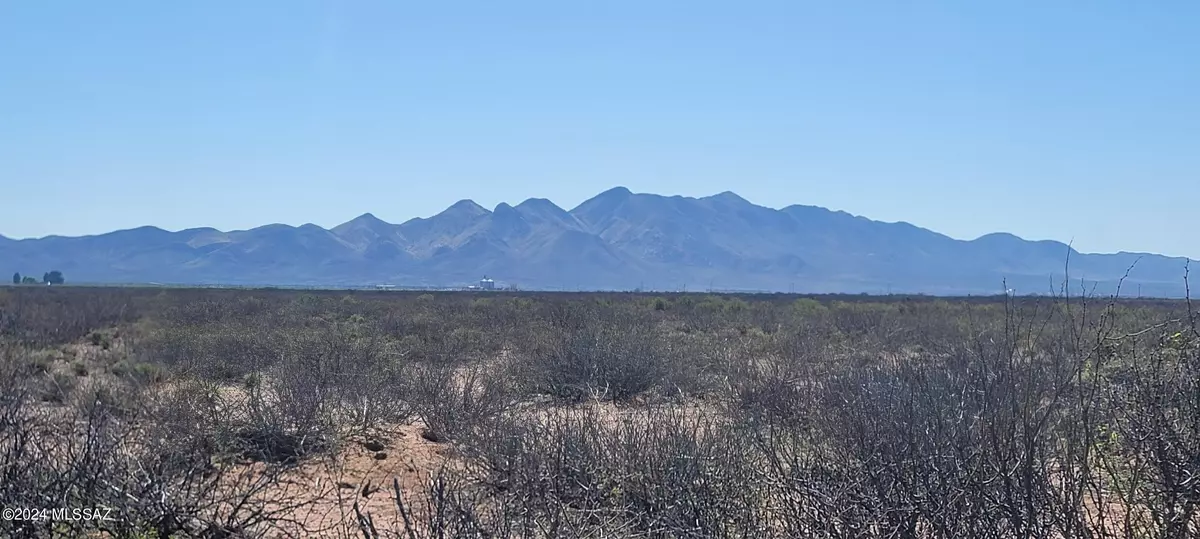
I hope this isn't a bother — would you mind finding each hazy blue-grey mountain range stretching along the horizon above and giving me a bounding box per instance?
[0,187,1187,297]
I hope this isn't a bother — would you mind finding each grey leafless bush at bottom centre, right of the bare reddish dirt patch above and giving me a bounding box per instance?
[368,409,764,538]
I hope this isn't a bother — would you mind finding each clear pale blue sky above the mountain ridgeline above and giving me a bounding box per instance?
[0,0,1200,258]
